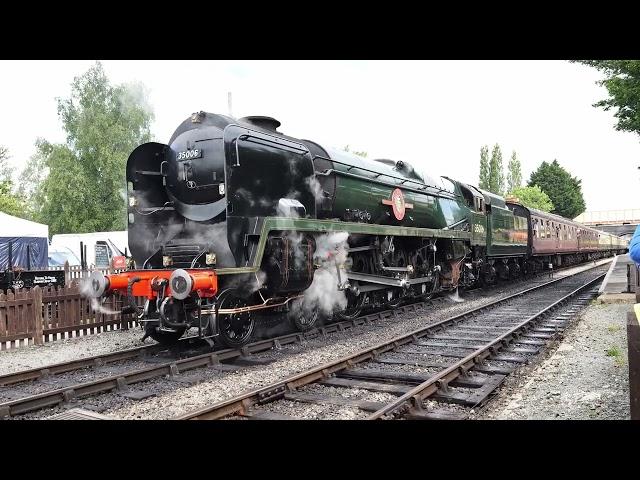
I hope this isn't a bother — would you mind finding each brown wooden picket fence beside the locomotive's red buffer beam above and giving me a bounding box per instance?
[0,266,144,350]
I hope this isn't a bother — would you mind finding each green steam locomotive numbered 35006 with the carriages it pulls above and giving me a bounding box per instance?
[91,112,626,347]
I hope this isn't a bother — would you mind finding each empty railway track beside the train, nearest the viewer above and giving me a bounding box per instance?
[176,267,605,420]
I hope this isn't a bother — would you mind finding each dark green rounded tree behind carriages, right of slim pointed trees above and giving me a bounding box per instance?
[528,160,586,218]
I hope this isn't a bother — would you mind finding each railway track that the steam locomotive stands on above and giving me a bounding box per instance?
[0,258,608,418]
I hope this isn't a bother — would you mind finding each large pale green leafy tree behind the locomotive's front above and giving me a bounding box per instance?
[20,62,153,234]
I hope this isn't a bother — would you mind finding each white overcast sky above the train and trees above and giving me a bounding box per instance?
[0,60,640,211]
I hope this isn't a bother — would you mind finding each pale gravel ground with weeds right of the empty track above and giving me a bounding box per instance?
[477,304,631,420]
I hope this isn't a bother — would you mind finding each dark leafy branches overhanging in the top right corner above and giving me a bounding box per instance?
[580,60,640,135]
